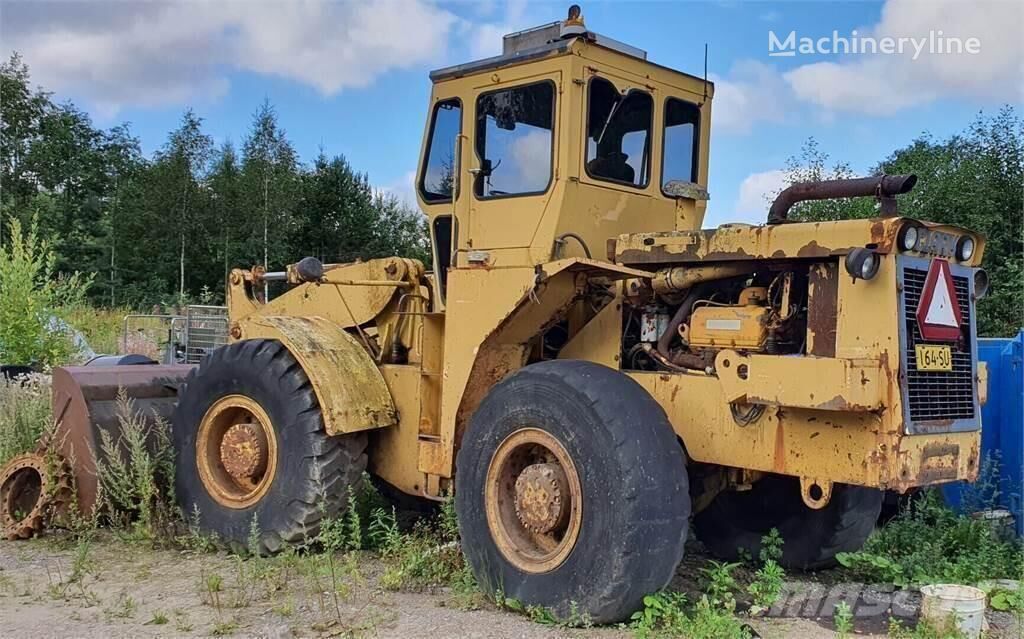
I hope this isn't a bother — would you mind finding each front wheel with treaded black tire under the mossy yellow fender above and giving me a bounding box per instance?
[173,340,367,553]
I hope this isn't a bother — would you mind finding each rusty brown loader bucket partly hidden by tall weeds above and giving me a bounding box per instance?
[52,365,195,515]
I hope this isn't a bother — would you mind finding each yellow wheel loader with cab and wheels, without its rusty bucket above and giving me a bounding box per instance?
[173,6,987,623]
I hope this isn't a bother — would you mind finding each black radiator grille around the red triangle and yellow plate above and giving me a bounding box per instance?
[903,266,975,422]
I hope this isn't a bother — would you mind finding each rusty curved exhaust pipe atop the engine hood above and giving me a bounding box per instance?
[768,174,918,224]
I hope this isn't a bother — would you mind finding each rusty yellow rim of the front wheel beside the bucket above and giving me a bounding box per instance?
[196,395,278,508]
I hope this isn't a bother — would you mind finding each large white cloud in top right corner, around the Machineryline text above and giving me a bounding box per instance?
[784,0,1024,116]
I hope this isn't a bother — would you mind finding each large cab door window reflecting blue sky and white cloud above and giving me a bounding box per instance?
[474,82,555,198]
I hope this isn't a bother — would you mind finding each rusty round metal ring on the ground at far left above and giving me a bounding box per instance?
[0,443,75,540]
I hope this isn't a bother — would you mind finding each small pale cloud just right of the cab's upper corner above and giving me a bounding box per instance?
[711,60,793,133]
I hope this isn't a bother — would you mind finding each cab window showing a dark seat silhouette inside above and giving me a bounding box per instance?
[587,78,654,187]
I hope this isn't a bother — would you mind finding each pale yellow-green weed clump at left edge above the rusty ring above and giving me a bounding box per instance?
[0,375,53,466]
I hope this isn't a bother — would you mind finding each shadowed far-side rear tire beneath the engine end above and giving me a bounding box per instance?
[693,475,883,570]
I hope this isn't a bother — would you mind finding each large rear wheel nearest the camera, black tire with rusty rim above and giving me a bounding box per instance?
[456,360,690,623]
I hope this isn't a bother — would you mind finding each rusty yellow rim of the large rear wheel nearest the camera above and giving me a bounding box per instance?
[484,428,583,572]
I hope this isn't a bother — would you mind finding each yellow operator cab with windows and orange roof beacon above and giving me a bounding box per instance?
[417,5,714,297]
